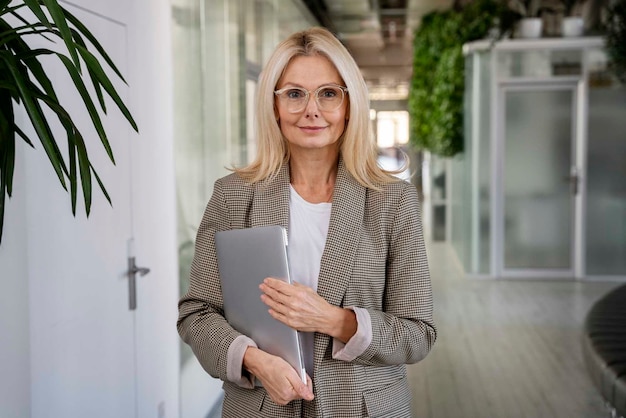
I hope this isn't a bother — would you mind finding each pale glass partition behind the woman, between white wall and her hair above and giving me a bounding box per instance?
[171,0,316,418]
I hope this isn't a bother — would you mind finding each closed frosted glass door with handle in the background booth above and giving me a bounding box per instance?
[499,84,578,278]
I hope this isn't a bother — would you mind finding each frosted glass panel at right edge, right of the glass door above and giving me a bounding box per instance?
[586,50,626,276]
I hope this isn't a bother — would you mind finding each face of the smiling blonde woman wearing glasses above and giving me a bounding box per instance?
[275,55,348,153]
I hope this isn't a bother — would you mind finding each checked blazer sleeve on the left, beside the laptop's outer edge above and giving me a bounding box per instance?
[177,180,254,386]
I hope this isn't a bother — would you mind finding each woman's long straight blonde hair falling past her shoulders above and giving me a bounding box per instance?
[234,27,401,190]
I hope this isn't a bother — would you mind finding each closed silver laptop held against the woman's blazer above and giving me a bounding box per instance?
[215,226,306,384]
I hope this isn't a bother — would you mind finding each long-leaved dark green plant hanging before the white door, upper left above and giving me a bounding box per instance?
[0,0,137,242]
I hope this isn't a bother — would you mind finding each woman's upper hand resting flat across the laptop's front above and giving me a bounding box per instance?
[259,277,357,343]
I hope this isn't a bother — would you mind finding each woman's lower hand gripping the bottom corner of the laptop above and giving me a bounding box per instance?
[243,347,313,405]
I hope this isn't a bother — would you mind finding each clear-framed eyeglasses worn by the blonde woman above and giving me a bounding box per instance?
[274,84,348,113]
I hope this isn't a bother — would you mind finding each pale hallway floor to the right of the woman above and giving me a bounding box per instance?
[409,243,620,418]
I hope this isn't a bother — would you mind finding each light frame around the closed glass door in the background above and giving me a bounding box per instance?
[491,77,587,279]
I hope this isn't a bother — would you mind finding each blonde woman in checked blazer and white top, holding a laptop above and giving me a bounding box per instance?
[178,28,436,418]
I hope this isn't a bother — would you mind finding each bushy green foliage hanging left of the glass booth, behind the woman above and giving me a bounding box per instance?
[409,0,504,157]
